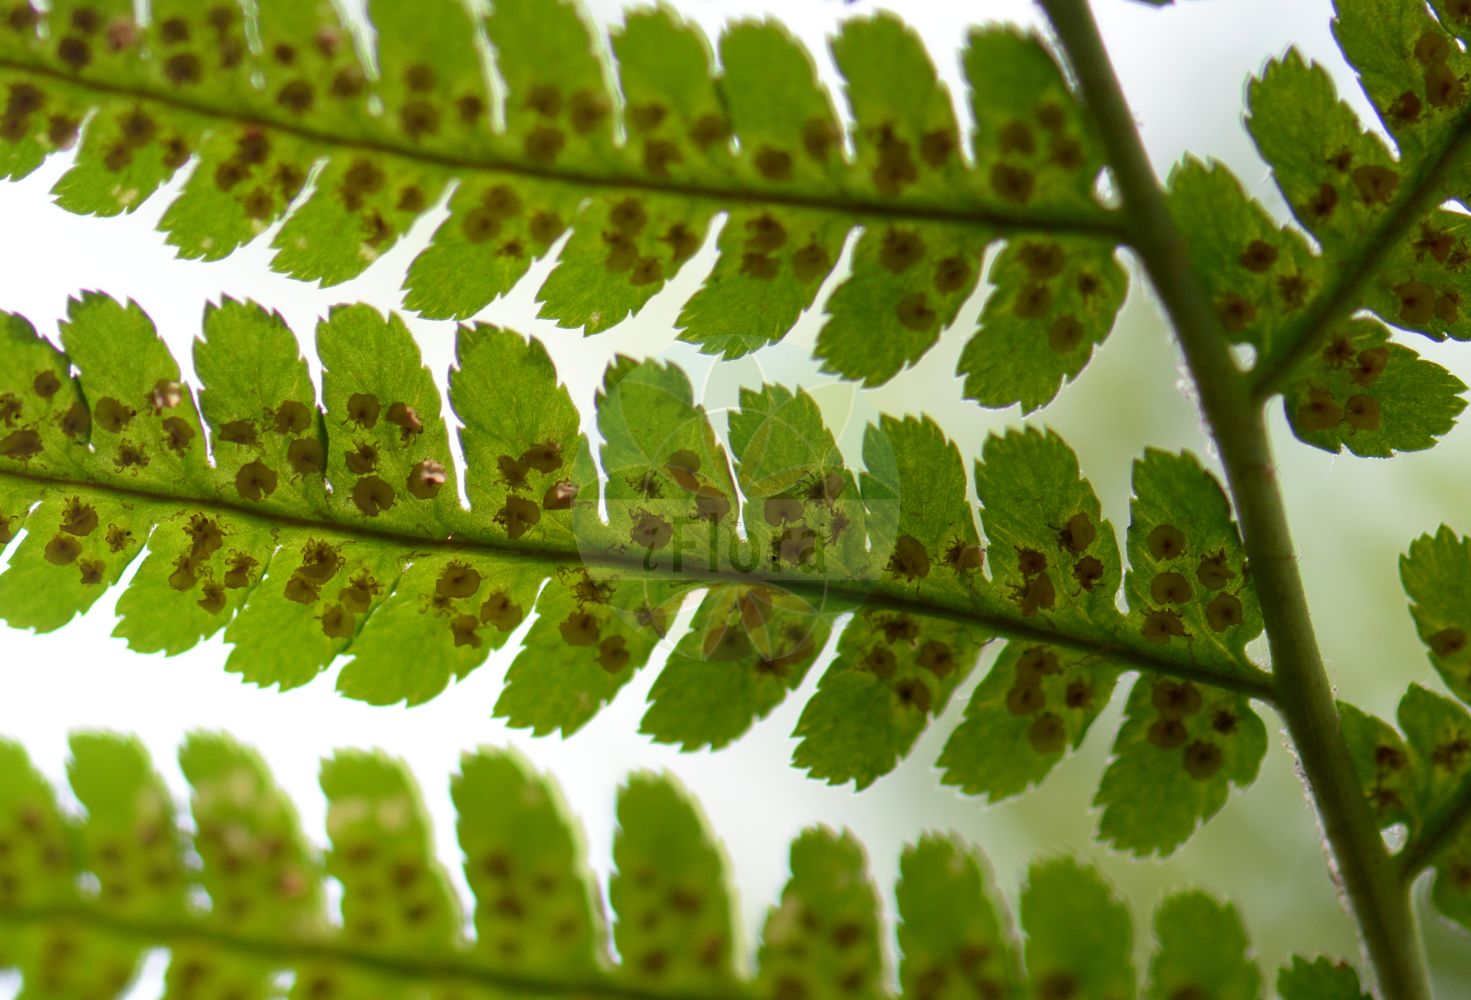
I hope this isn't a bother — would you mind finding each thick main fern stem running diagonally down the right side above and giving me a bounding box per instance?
[1039,0,1430,1000]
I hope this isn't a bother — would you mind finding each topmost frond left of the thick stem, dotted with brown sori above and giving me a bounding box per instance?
[0,0,1125,410]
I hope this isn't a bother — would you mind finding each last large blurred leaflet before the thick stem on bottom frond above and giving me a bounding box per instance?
[1144,893,1262,1000]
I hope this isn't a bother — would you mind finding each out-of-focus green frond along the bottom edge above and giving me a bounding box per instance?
[0,734,1335,1000]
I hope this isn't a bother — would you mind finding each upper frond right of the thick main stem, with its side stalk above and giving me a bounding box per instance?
[1217,0,1471,438]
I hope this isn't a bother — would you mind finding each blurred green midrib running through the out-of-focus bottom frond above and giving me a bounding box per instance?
[0,903,750,1000]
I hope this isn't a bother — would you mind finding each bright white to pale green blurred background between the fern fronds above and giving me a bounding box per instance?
[0,0,1471,997]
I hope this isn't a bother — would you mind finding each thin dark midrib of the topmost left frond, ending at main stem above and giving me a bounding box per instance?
[0,59,1124,240]
